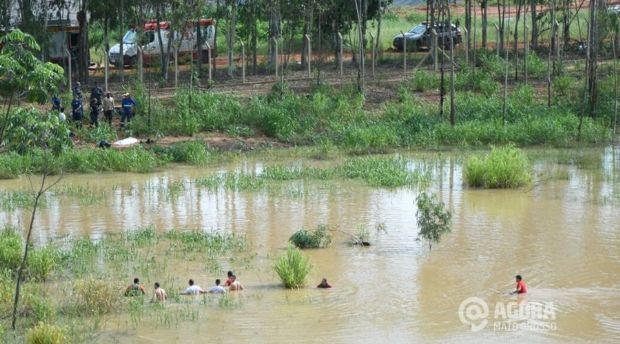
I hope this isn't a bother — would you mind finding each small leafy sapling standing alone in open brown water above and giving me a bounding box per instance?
[416,192,452,251]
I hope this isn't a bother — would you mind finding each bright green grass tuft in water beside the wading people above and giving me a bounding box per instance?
[274,245,312,289]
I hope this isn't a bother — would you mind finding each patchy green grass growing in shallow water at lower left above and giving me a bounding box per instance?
[0,228,251,343]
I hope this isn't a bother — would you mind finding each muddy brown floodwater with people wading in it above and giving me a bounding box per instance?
[0,147,620,343]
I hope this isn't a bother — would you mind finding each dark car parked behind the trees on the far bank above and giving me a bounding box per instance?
[392,23,462,51]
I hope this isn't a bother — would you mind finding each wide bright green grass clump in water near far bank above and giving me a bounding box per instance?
[465,146,531,189]
